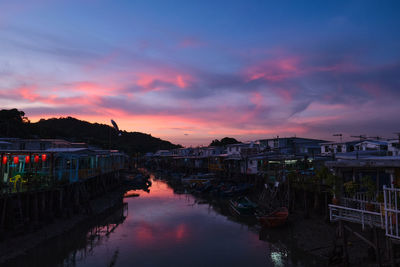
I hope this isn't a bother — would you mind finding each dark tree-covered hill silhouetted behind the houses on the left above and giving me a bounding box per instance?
[0,109,181,154]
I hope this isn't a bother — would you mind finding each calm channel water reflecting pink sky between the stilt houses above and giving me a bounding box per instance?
[3,177,318,267]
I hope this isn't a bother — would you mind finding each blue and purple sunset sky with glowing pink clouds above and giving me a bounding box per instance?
[0,0,400,146]
